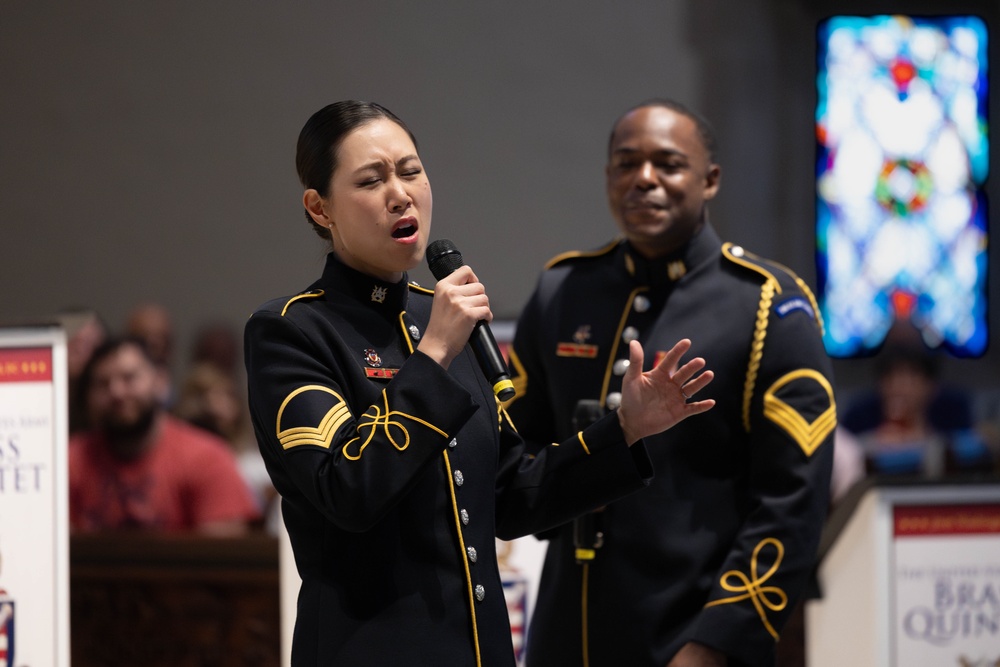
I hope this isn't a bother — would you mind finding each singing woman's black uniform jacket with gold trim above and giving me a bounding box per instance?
[245,254,651,666]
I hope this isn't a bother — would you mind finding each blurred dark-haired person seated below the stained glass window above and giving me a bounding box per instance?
[841,341,991,477]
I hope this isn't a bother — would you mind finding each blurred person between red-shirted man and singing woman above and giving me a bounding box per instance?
[174,361,277,511]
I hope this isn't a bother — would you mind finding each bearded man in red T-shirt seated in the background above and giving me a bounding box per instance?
[69,338,259,536]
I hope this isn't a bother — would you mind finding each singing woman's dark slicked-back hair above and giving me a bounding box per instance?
[295,100,417,240]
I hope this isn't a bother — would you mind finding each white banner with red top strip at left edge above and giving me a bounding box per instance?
[0,327,69,667]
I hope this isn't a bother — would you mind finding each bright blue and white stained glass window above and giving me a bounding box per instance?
[816,16,989,357]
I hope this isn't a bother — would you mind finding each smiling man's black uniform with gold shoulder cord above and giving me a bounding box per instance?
[507,224,836,667]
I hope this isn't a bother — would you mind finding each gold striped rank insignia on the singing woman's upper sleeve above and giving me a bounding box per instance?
[276,385,351,449]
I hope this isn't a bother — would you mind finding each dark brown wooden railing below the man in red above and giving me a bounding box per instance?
[69,533,280,667]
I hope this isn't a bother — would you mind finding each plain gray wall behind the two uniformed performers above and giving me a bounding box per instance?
[0,0,1000,396]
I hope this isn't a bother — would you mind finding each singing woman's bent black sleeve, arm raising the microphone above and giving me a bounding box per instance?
[245,312,476,531]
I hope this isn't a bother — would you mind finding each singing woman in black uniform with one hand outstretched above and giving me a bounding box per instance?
[245,101,713,667]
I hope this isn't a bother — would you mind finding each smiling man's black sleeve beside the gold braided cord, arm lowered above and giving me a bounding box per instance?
[686,284,836,664]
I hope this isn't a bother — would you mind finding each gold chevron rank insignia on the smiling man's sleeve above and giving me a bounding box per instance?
[764,368,837,456]
